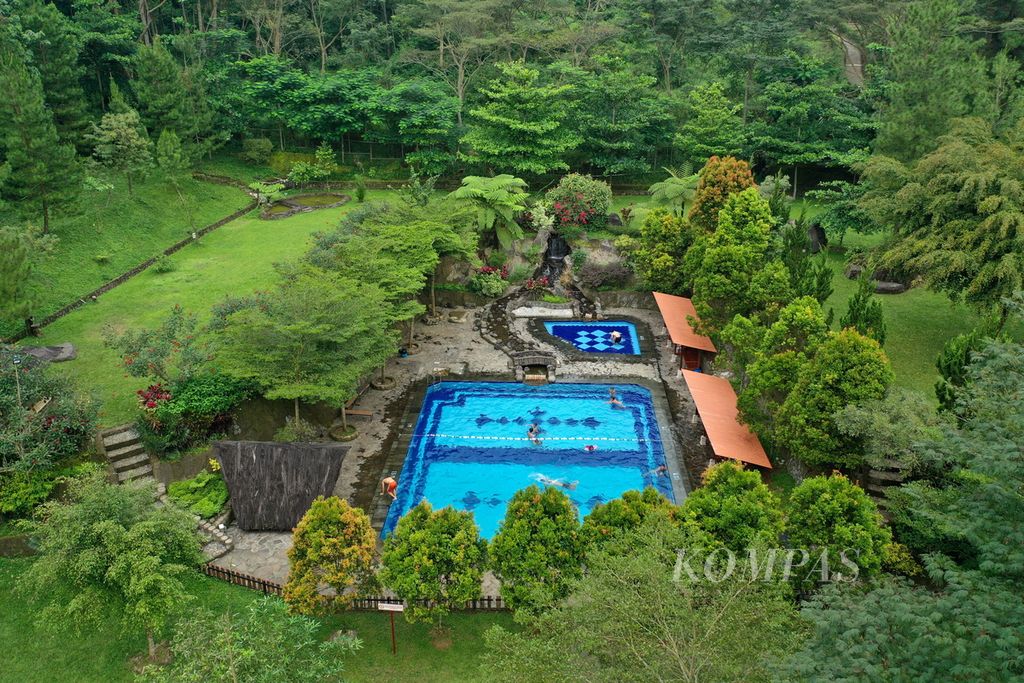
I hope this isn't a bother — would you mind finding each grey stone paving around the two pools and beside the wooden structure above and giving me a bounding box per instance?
[217,301,699,595]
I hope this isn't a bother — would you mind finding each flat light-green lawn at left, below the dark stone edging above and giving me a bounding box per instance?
[24,190,393,426]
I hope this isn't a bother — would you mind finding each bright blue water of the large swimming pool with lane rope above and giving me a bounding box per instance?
[383,382,675,538]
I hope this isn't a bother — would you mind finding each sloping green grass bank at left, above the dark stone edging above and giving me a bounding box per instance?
[0,176,250,335]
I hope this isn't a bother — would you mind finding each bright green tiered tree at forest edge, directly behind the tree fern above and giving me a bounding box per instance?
[462,61,583,175]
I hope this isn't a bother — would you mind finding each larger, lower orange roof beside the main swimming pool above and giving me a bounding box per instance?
[683,370,771,469]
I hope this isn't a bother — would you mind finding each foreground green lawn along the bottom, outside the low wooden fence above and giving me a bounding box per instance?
[0,558,512,683]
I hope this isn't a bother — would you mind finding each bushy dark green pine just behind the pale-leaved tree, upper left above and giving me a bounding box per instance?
[132,39,193,139]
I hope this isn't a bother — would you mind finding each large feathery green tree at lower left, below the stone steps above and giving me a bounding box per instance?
[17,472,201,658]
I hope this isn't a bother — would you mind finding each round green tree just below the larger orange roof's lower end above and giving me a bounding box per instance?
[683,462,782,552]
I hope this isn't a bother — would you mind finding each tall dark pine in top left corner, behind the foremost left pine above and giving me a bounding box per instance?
[18,0,89,152]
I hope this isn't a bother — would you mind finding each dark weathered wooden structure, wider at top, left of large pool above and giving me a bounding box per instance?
[213,441,348,531]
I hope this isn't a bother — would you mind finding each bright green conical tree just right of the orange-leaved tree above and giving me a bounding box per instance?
[685,187,793,332]
